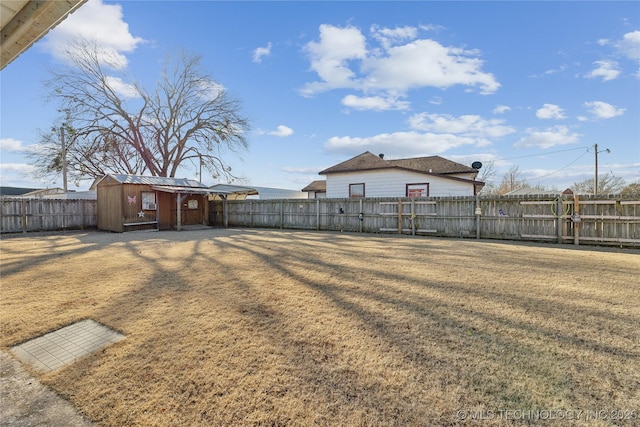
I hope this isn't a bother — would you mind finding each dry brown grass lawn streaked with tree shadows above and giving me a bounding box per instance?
[0,229,640,426]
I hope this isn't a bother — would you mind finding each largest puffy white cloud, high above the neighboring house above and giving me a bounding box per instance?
[301,24,500,98]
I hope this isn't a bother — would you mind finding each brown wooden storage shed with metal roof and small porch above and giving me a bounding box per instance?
[95,174,211,233]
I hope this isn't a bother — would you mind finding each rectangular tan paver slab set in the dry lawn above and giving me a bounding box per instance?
[10,319,124,372]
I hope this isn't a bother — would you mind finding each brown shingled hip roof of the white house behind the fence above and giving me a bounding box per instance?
[320,151,478,175]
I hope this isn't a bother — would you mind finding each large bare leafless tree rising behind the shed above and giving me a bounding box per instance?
[33,42,249,184]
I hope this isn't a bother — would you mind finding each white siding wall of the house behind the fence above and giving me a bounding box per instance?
[327,169,473,198]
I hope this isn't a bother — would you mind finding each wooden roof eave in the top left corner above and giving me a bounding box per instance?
[0,0,87,70]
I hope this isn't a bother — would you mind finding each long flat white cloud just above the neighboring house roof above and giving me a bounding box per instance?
[324,131,482,157]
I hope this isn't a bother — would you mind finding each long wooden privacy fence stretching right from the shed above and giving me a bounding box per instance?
[215,195,640,247]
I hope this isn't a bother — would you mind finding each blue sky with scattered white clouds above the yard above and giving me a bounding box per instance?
[0,0,640,190]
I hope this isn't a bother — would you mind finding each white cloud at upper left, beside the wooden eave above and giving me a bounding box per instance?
[43,0,144,69]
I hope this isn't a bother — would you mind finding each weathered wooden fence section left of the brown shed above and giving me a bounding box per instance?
[0,198,98,233]
